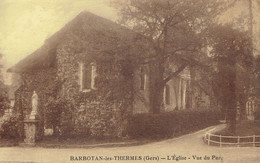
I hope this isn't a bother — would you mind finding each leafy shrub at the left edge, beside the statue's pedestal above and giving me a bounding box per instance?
[0,114,19,139]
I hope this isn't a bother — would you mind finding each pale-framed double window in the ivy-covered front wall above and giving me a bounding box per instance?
[80,63,96,91]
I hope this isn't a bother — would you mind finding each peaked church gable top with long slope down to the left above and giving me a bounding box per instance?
[8,11,136,73]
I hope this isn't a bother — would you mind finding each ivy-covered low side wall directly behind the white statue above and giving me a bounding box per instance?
[15,68,58,137]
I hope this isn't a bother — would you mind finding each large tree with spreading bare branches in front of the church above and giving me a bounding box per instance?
[112,0,237,113]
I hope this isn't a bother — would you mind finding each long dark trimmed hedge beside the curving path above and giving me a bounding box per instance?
[127,109,221,139]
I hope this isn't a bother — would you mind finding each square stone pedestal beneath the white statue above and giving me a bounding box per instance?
[22,119,39,146]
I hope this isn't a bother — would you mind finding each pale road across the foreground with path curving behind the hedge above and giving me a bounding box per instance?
[0,124,260,163]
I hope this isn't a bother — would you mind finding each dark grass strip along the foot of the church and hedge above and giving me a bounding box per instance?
[0,125,215,148]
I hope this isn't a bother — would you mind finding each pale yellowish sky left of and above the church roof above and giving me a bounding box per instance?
[0,0,116,66]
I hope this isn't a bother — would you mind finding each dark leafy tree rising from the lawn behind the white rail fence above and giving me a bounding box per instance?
[205,24,254,132]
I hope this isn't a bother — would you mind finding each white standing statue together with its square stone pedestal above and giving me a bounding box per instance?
[23,91,39,146]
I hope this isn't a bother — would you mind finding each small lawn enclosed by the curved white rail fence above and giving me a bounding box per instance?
[215,121,260,136]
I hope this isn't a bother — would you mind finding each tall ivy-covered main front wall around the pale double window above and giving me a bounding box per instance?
[52,13,138,137]
